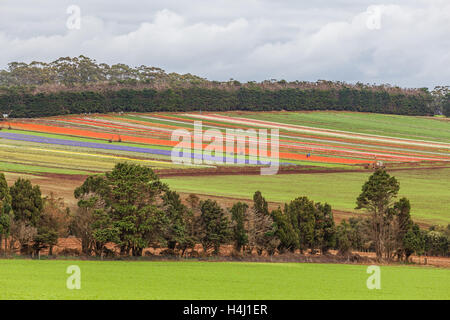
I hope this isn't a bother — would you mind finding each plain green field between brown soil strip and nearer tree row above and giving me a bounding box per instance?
[163,169,450,223]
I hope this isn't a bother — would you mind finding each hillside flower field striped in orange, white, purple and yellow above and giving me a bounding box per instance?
[0,113,450,173]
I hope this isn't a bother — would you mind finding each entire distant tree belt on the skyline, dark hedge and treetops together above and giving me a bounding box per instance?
[0,56,442,117]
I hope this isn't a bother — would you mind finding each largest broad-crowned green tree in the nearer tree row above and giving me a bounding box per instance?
[74,163,168,256]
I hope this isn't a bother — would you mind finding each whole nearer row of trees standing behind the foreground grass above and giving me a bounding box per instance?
[0,163,450,261]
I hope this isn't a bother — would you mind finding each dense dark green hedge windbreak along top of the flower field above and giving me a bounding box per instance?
[0,87,434,118]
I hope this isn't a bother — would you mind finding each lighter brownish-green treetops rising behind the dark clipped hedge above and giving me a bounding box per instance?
[0,55,432,95]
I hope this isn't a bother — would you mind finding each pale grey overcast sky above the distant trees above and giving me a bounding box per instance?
[0,0,450,88]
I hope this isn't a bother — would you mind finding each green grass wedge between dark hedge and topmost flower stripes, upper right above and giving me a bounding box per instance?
[229,111,450,143]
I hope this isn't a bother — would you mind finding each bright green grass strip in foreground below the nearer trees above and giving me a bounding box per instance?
[0,260,450,299]
